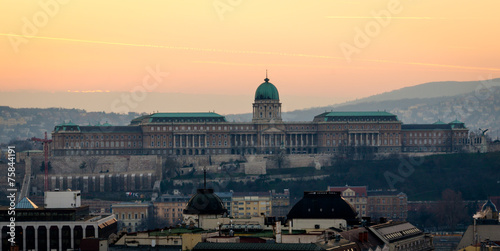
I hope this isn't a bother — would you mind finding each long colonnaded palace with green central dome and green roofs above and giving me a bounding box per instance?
[51,78,469,156]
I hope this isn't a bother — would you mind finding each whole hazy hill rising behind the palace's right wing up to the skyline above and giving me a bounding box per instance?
[226,78,500,137]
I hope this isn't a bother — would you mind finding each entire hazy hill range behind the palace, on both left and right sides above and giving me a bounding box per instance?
[0,78,500,143]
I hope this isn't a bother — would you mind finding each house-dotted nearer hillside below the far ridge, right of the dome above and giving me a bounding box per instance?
[226,87,500,139]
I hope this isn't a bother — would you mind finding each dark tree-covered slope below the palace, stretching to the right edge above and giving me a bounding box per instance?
[162,152,500,200]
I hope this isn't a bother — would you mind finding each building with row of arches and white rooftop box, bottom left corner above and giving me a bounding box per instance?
[0,191,117,251]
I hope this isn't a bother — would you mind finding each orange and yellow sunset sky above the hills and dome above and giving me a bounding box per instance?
[0,0,500,114]
